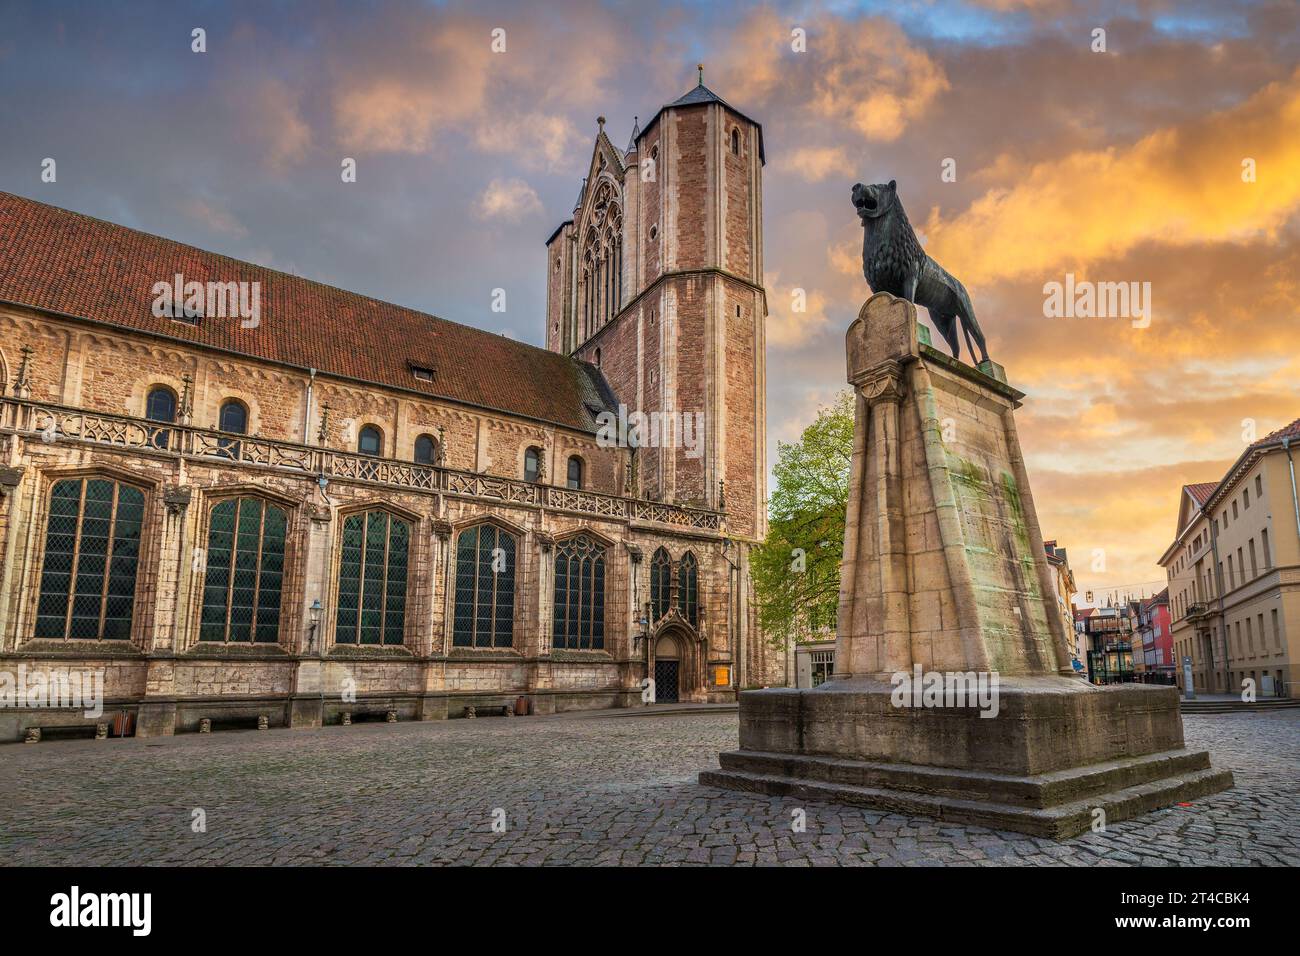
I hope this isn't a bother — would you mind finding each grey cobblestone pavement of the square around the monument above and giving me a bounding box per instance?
[0,710,1300,866]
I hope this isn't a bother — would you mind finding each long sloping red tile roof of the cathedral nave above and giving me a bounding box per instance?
[0,193,614,432]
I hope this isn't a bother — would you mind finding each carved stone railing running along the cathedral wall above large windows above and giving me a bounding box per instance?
[0,397,723,532]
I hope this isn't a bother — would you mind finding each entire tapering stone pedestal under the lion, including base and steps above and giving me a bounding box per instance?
[701,293,1232,838]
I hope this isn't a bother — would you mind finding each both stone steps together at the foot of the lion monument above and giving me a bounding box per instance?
[699,750,1232,839]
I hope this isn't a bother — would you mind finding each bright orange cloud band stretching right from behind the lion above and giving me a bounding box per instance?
[926,70,1300,284]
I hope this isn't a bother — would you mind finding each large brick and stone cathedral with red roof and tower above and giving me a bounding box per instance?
[0,77,792,740]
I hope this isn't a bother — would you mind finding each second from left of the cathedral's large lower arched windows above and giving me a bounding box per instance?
[199,498,287,644]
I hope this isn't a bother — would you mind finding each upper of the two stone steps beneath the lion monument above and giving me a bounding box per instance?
[718,750,1210,809]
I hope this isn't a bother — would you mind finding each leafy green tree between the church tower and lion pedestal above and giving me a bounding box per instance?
[750,392,853,645]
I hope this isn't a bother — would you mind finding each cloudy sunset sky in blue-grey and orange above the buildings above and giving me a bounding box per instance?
[0,0,1300,604]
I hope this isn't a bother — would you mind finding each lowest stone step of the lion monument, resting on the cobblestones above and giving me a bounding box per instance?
[699,769,1232,840]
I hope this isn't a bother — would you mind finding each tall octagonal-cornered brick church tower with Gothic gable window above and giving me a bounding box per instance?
[546,68,767,546]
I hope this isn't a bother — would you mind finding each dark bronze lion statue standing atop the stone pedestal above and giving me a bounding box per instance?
[853,179,988,362]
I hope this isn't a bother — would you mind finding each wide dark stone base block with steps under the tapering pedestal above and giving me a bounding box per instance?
[699,676,1232,839]
